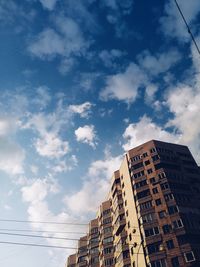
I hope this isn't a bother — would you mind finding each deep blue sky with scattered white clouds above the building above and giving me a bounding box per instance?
[0,0,200,267]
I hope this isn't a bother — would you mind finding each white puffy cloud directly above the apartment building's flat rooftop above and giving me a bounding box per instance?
[123,116,181,151]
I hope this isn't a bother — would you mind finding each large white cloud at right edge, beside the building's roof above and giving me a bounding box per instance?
[162,38,200,163]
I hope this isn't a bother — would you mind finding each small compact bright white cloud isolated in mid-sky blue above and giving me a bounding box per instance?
[75,125,97,148]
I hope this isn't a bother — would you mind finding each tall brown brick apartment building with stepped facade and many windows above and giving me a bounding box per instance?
[66,140,200,267]
